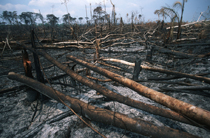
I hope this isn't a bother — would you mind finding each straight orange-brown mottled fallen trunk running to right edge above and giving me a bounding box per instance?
[67,55,210,128]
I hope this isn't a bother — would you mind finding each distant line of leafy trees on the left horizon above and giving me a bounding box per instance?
[0,6,109,26]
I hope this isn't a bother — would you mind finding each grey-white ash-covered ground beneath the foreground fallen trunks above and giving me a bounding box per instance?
[0,44,210,138]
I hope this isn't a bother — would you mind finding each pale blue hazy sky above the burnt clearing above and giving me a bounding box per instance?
[0,0,210,22]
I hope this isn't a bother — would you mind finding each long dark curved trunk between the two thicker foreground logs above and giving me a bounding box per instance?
[16,46,197,126]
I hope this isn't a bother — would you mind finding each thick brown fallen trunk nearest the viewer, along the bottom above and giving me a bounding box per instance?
[8,72,197,138]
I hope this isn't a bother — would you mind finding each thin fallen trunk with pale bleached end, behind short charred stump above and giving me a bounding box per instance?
[102,58,210,83]
